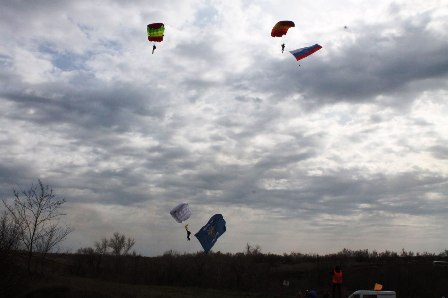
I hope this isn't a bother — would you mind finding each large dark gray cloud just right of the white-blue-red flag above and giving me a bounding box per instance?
[228,16,448,106]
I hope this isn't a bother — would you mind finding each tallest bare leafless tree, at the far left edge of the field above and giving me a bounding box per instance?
[3,179,72,272]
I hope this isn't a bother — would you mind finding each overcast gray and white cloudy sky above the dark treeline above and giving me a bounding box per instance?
[0,0,448,256]
